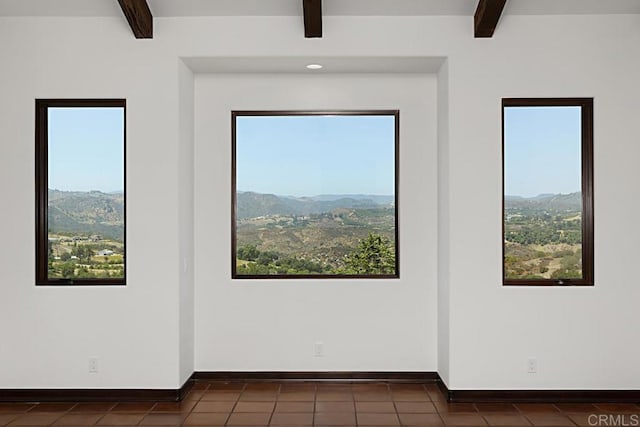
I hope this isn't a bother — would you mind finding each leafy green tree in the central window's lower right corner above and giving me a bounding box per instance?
[344,233,396,274]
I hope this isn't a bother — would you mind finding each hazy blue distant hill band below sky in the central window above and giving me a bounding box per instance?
[236,191,394,219]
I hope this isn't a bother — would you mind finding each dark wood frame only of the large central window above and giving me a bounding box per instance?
[231,110,400,280]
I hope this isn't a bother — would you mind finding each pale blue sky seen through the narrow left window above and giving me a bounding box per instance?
[48,107,124,192]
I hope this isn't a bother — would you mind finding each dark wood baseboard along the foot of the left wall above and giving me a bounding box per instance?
[0,375,194,402]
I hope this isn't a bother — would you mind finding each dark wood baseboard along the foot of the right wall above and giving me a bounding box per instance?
[438,381,640,403]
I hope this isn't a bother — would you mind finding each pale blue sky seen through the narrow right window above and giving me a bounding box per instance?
[504,107,581,197]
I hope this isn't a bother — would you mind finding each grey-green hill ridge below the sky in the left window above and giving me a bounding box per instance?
[48,189,124,240]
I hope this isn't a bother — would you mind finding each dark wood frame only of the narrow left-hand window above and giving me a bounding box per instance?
[35,99,127,286]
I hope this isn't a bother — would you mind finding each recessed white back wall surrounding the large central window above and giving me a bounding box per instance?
[195,75,437,371]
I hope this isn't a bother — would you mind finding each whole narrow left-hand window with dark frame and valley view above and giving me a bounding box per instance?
[36,99,126,285]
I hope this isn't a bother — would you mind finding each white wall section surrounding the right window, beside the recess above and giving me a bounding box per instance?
[448,16,640,389]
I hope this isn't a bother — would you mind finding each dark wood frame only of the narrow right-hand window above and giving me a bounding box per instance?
[502,98,594,286]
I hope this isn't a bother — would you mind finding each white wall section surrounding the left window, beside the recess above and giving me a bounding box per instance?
[0,19,185,388]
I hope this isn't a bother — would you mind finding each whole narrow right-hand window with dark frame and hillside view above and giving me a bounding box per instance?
[502,98,593,286]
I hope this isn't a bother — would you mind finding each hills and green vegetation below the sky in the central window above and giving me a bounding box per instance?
[236,192,395,275]
